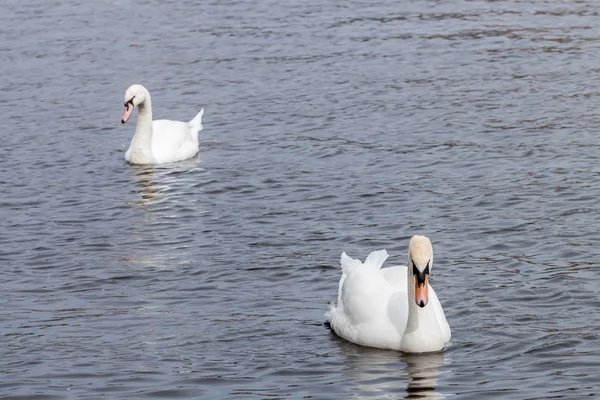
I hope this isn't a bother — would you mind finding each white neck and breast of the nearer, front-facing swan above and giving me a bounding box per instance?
[400,268,444,353]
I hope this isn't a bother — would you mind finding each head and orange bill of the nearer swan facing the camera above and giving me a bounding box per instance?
[408,236,433,308]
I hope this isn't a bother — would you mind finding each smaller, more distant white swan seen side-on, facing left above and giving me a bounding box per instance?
[121,85,204,164]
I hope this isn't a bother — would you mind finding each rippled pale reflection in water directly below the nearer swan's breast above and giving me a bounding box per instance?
[402,352,445,399]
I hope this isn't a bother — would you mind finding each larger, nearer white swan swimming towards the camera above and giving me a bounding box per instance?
[325,236,450,353]
